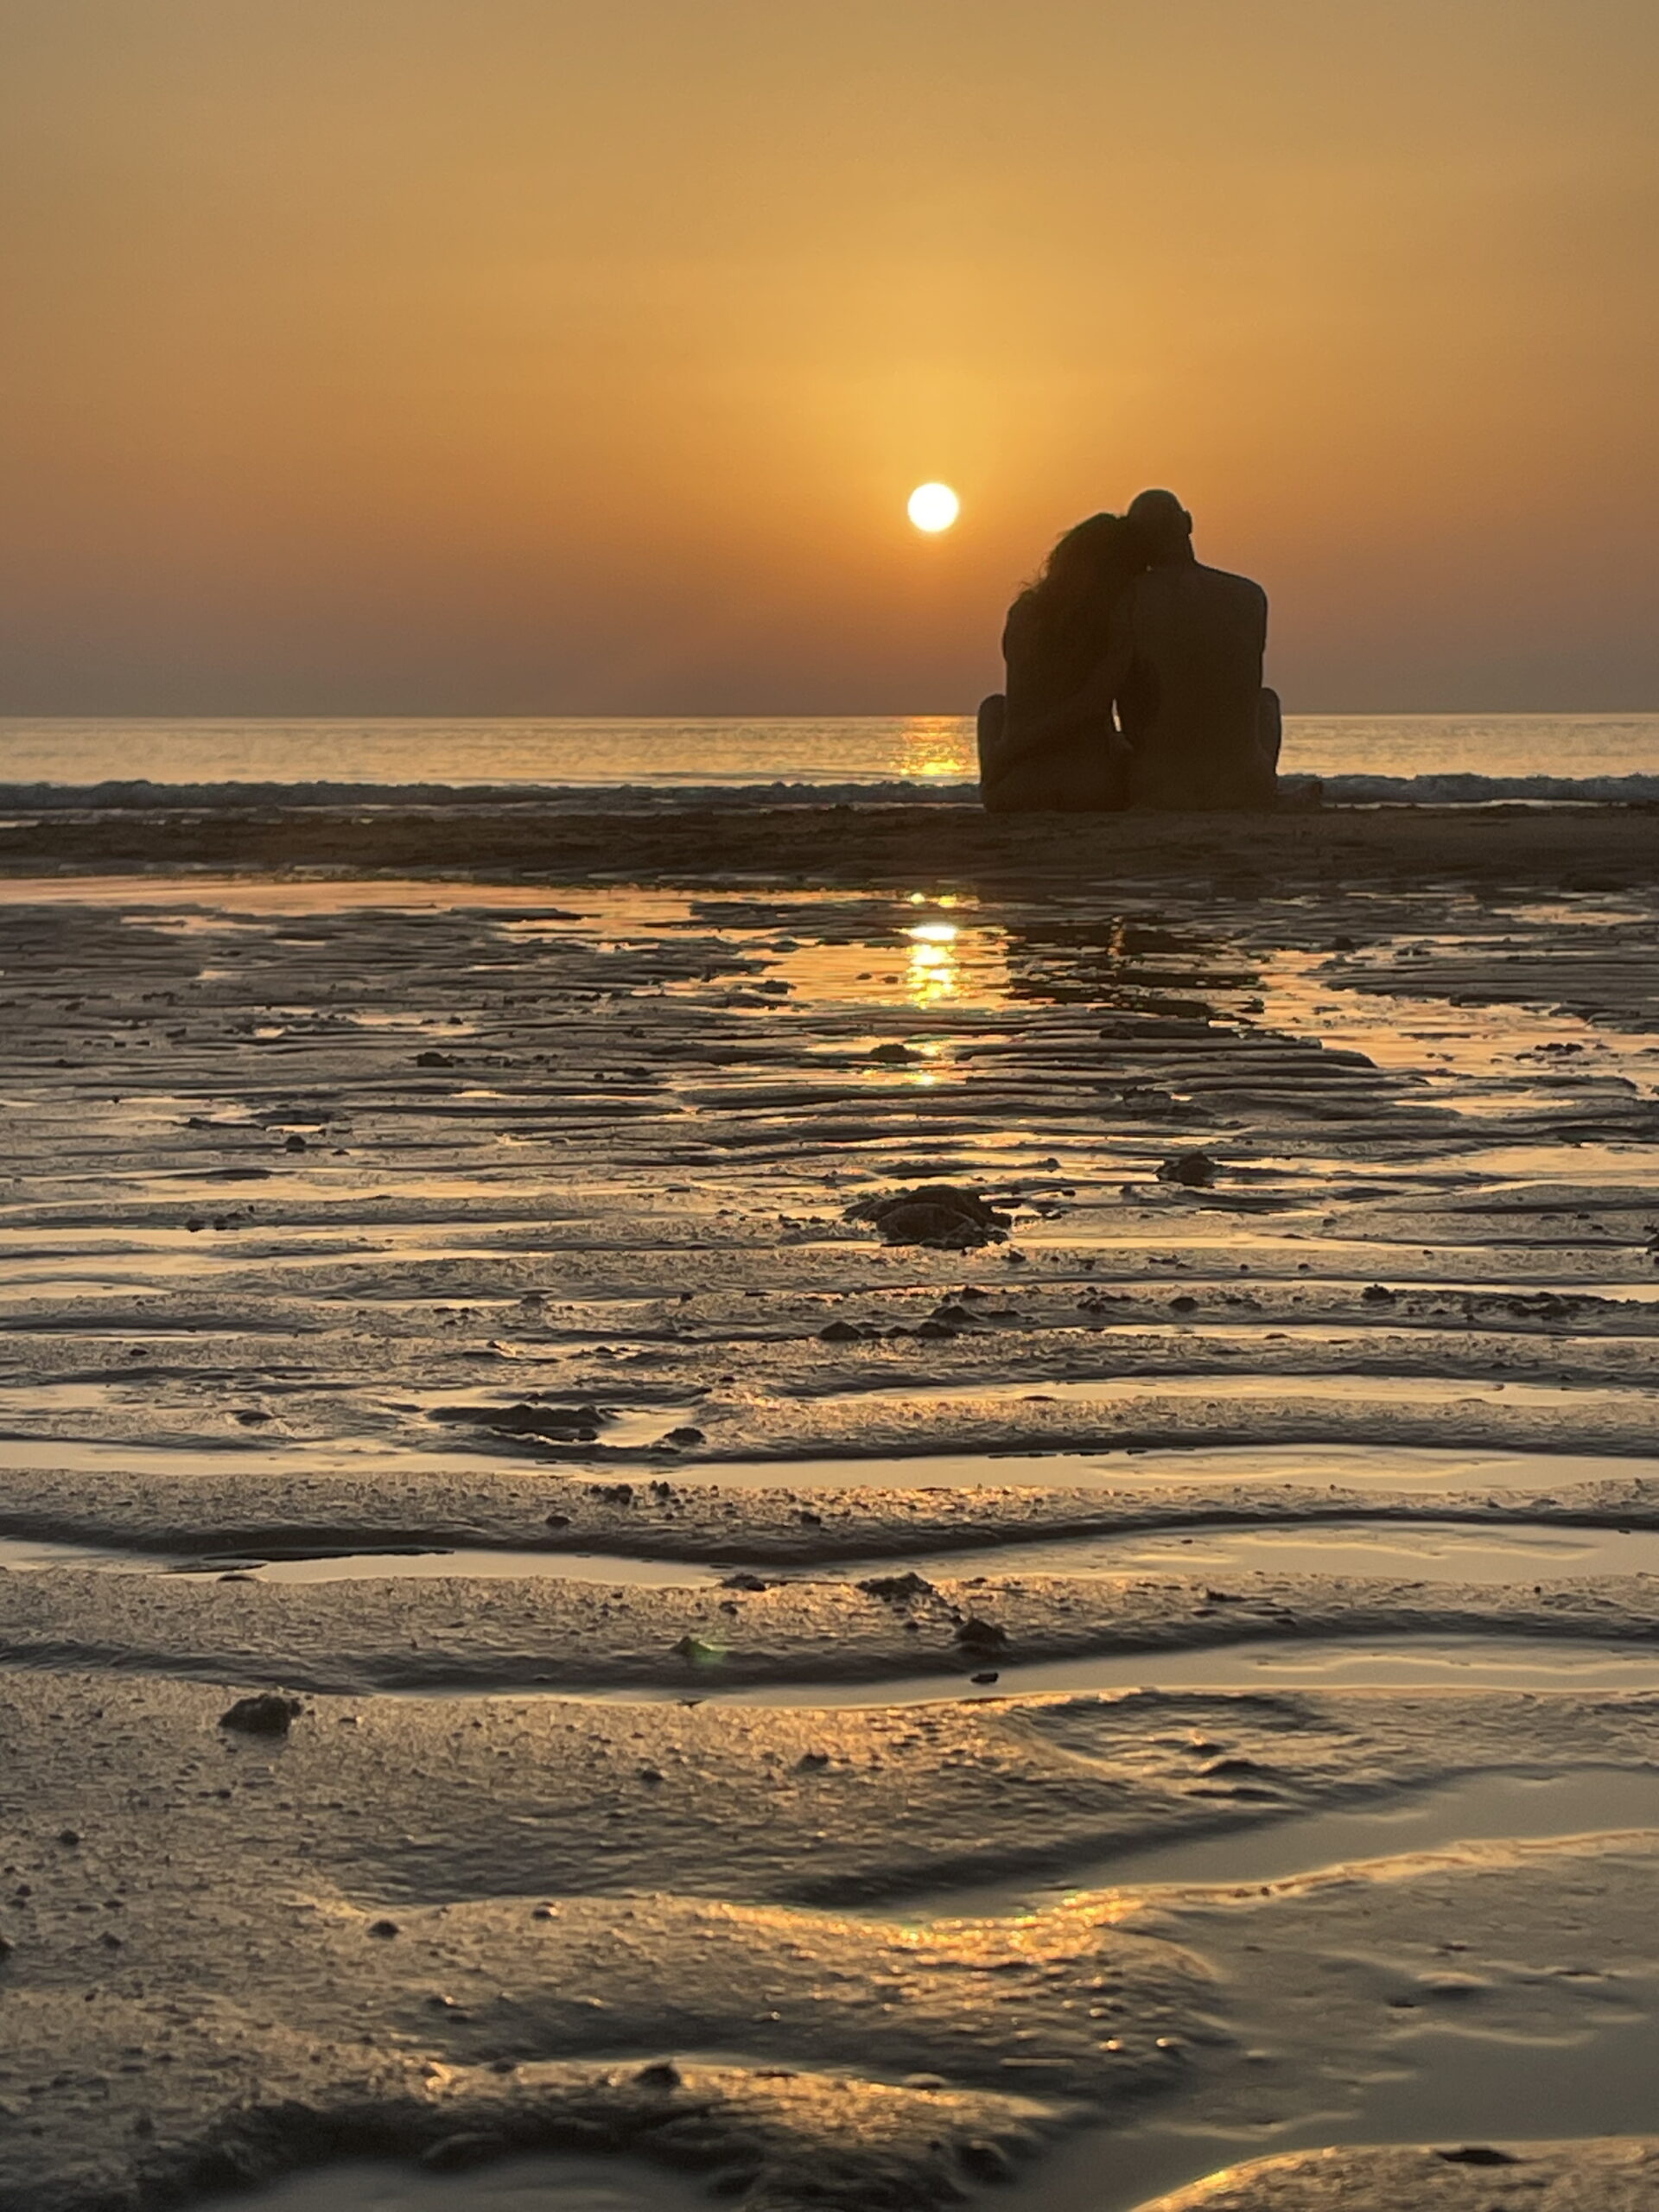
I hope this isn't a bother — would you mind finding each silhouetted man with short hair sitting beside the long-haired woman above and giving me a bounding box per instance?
[1106,491,1279,810]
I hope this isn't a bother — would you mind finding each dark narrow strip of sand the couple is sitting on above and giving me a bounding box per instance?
[0,803,1659,902]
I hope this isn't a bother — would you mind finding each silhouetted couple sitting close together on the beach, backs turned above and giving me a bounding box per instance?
[980,491,1281,814]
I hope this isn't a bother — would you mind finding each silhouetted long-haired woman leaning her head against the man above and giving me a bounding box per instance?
[980,515,1146,814]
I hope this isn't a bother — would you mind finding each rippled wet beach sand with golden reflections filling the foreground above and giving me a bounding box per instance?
[0,805,1659,2212]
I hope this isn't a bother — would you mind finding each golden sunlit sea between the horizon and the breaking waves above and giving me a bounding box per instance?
[0,715,1659,790]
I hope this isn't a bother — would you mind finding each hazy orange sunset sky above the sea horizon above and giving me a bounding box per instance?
[0,0,1659,715]
